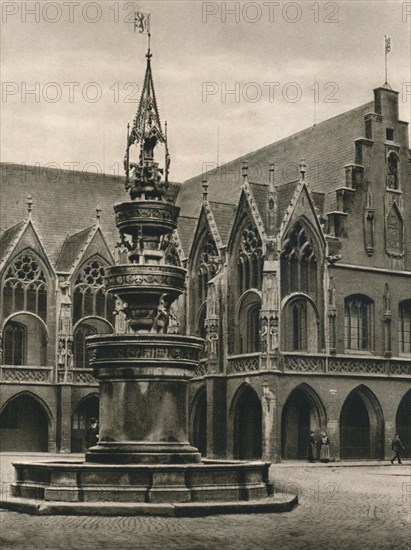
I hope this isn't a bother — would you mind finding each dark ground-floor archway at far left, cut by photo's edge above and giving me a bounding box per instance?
[0,395,49,453]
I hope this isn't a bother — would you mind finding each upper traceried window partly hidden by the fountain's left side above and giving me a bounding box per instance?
[73,258,115,323]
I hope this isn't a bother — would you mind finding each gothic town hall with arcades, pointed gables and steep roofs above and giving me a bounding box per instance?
[0,86,411,462]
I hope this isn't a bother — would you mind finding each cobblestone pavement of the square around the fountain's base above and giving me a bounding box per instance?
[0,455,411,550]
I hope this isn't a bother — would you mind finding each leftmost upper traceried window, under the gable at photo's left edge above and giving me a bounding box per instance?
[3,251,47,321]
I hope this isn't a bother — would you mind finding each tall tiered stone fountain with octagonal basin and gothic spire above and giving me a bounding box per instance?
[2,47,296,515]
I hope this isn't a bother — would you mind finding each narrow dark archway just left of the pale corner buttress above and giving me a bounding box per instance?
[234,386,263,460]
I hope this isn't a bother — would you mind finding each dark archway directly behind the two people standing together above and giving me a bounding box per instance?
[281,387,323,460]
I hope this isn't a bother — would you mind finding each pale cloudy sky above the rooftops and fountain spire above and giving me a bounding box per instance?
[0,0,411,181]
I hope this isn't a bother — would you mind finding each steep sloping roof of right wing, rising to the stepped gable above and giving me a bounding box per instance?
[177,101,374,217]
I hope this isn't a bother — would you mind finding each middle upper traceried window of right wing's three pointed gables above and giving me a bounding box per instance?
[237,218,263,296]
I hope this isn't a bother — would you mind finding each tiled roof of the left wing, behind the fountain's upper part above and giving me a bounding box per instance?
[0,163,181,271]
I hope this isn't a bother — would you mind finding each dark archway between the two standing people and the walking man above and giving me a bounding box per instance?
[340,387,384,459]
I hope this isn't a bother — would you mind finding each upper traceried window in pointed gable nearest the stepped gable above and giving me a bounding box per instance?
[281,222,318,301]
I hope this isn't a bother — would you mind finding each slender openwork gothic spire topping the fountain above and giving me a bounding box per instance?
[124,48,170,200]
